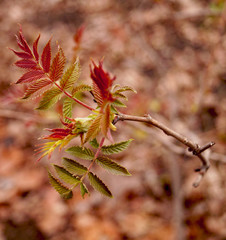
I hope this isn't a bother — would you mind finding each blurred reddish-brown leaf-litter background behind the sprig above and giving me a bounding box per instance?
[0,0,226,240]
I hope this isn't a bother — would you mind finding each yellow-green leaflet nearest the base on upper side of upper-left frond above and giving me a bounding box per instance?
[60,58,81,90]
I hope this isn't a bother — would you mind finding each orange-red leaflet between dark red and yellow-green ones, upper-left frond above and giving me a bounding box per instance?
[50,47,66,81]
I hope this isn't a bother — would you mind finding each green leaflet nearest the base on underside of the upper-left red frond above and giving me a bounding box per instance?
[37,87,62,110]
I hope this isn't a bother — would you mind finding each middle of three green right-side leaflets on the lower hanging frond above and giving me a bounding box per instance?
[96,157,131,176]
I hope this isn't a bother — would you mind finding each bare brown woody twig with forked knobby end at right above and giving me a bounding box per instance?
[113,113,215,187]
